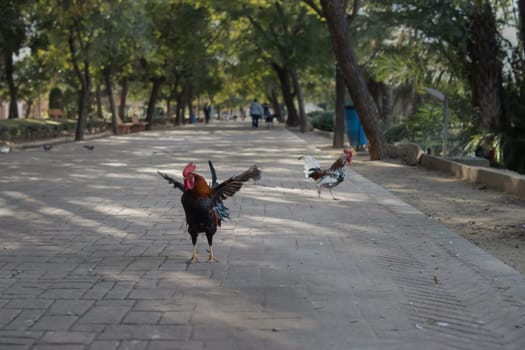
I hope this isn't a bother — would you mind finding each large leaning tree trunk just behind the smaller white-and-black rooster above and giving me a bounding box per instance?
[321,0,387,160]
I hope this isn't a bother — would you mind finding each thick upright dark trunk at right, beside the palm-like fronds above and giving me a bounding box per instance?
[468,1,503,133]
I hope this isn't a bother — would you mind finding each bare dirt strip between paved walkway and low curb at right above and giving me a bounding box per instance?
[298,133,525,274]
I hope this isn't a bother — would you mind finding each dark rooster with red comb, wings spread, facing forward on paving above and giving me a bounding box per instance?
[158,161,261,262]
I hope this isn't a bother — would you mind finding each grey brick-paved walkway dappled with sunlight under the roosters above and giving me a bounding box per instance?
[0,122,525,350]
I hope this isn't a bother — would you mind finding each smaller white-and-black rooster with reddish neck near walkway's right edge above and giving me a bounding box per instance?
[302,149,352,199]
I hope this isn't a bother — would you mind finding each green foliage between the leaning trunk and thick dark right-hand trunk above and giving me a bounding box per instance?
[354,0,475,123]
